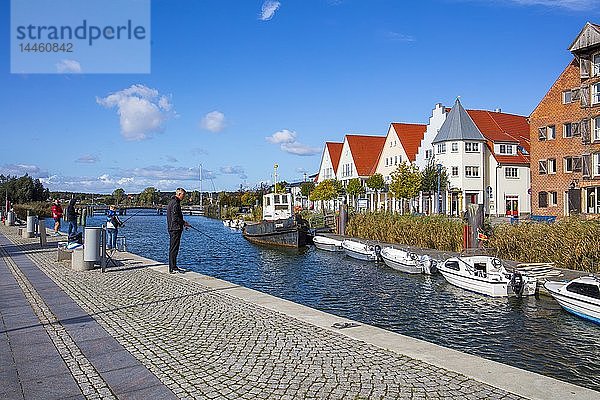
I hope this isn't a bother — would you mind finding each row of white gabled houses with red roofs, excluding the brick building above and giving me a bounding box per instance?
[317,99,530,215]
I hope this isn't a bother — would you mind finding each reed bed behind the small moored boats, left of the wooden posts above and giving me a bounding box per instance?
[346,212,463,251]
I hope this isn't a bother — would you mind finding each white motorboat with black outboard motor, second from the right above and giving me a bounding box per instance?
[437,256,537,297]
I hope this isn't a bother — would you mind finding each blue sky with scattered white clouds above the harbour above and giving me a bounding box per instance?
[0,0,600,193]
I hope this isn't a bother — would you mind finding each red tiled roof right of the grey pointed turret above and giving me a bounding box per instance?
[467,110,529,164]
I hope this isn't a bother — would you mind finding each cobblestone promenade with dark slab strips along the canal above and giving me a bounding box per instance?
[0,226,592,399]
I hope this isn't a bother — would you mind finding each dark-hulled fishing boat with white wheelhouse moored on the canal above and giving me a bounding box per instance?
[242,193,310,247]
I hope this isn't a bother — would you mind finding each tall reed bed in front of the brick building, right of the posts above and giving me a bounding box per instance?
[488,217,600,272]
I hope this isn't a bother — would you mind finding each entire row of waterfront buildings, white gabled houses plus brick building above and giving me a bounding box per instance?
[316,23,600,216]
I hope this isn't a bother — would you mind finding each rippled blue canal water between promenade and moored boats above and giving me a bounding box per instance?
[67,214,600,390]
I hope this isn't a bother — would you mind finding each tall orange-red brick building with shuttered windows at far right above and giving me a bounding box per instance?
[529,22,600,216]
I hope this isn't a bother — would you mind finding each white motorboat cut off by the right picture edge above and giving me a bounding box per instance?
[544,276,600,324]
